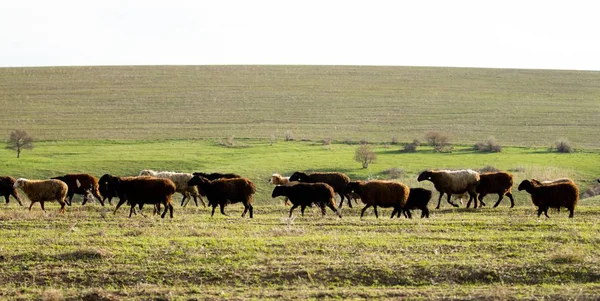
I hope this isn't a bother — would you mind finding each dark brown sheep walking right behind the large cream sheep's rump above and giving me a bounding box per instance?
[467,172,515,208]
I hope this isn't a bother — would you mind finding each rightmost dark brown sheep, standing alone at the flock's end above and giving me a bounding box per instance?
[518,180,579,218]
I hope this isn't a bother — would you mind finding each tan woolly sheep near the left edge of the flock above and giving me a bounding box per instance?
[13,178,69,213]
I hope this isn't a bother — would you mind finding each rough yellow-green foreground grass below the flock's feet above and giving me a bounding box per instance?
[0,199,600,300]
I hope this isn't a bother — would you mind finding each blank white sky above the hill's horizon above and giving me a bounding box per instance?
[0,0,600,70]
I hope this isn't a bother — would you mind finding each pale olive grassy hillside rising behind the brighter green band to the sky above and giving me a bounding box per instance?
[0,66,600,148]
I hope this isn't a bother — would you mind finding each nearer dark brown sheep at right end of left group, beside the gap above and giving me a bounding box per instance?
[188,175,256,218]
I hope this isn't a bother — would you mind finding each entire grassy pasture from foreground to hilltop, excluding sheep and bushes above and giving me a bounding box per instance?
[0,66,600,300]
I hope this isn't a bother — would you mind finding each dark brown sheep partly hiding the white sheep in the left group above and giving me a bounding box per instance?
[108,175,176,218]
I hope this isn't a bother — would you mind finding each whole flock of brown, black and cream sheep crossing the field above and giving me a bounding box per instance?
[0,170,580,218]
